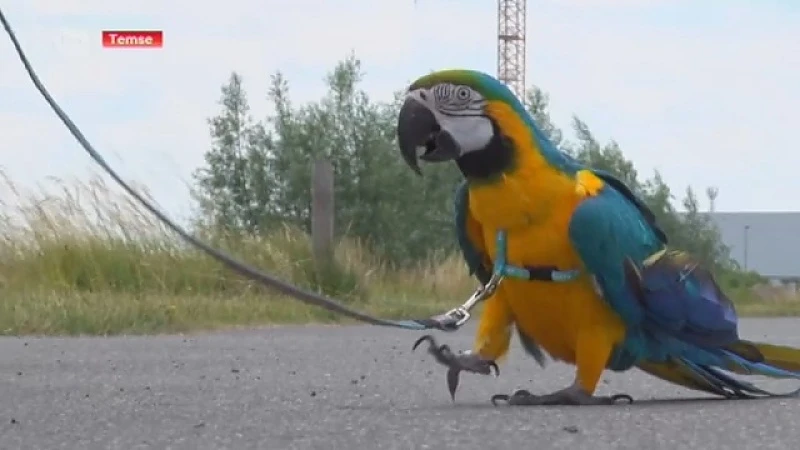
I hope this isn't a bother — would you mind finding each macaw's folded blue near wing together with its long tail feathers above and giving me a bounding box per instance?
[569,179,800,397]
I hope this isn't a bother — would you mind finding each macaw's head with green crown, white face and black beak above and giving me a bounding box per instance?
[397,70,527,179]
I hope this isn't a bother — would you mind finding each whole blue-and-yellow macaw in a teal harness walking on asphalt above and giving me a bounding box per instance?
[397,70,800,405]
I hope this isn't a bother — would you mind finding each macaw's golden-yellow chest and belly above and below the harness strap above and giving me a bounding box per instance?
[470,179,624,362]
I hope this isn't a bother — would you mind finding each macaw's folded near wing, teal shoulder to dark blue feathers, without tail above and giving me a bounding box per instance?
[569,184,738,353]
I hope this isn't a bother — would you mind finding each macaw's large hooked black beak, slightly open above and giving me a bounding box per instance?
[397,97,461,175]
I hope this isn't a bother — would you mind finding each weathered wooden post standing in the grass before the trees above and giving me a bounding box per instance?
[311,159,334,268]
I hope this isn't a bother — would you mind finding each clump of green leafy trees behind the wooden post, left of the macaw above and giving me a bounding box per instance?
[197,56,459,263]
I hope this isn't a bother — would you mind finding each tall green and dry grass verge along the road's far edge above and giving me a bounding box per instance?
[0,173,800,335]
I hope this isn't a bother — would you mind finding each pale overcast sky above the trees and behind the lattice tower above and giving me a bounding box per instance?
[0,0,800,219]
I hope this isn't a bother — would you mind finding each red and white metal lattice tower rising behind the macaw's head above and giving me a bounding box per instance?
[497,0,527,99]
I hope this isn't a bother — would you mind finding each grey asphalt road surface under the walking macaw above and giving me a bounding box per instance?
[0,320,800,450]
